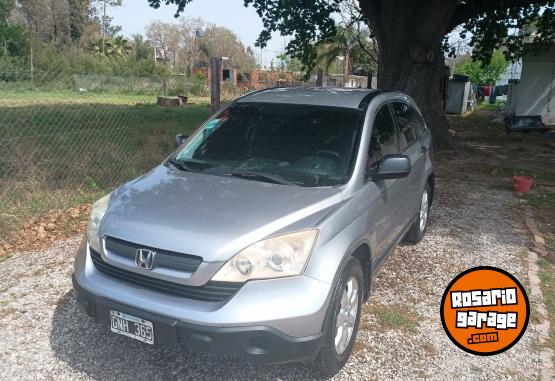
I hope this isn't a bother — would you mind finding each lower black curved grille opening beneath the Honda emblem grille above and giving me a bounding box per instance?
[90,249,241,302]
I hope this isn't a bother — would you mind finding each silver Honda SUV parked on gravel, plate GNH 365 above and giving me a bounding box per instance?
[73,88,434,375]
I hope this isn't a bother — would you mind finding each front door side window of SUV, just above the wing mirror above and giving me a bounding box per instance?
[367,105,399,173]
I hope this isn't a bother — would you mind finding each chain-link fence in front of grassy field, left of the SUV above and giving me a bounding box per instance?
[0,72,210,239]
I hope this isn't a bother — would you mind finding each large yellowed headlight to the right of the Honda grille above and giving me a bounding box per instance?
[212,229,318,282]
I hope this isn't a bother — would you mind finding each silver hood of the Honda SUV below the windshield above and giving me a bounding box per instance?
[100,165,342,262]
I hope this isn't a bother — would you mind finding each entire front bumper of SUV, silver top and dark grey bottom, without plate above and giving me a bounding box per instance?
[73,240,330,363]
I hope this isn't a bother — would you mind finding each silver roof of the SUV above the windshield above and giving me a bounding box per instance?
[237,87,378,109]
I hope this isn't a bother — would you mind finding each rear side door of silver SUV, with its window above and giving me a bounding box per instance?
[392,102,427,225]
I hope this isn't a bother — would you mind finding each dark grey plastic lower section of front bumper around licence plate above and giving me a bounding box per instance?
[73,277,323,364]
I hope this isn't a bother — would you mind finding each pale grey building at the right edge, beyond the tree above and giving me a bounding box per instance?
[505,45,555,125]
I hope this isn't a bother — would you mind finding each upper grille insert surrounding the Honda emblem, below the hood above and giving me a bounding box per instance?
[104,237,202,273]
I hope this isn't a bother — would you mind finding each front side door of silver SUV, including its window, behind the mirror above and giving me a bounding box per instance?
[365,104,403,259]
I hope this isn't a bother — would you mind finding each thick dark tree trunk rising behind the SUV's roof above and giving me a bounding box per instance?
[360,0,456,150]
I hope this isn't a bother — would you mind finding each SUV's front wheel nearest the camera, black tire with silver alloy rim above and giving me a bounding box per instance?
[314,257,364,378]
